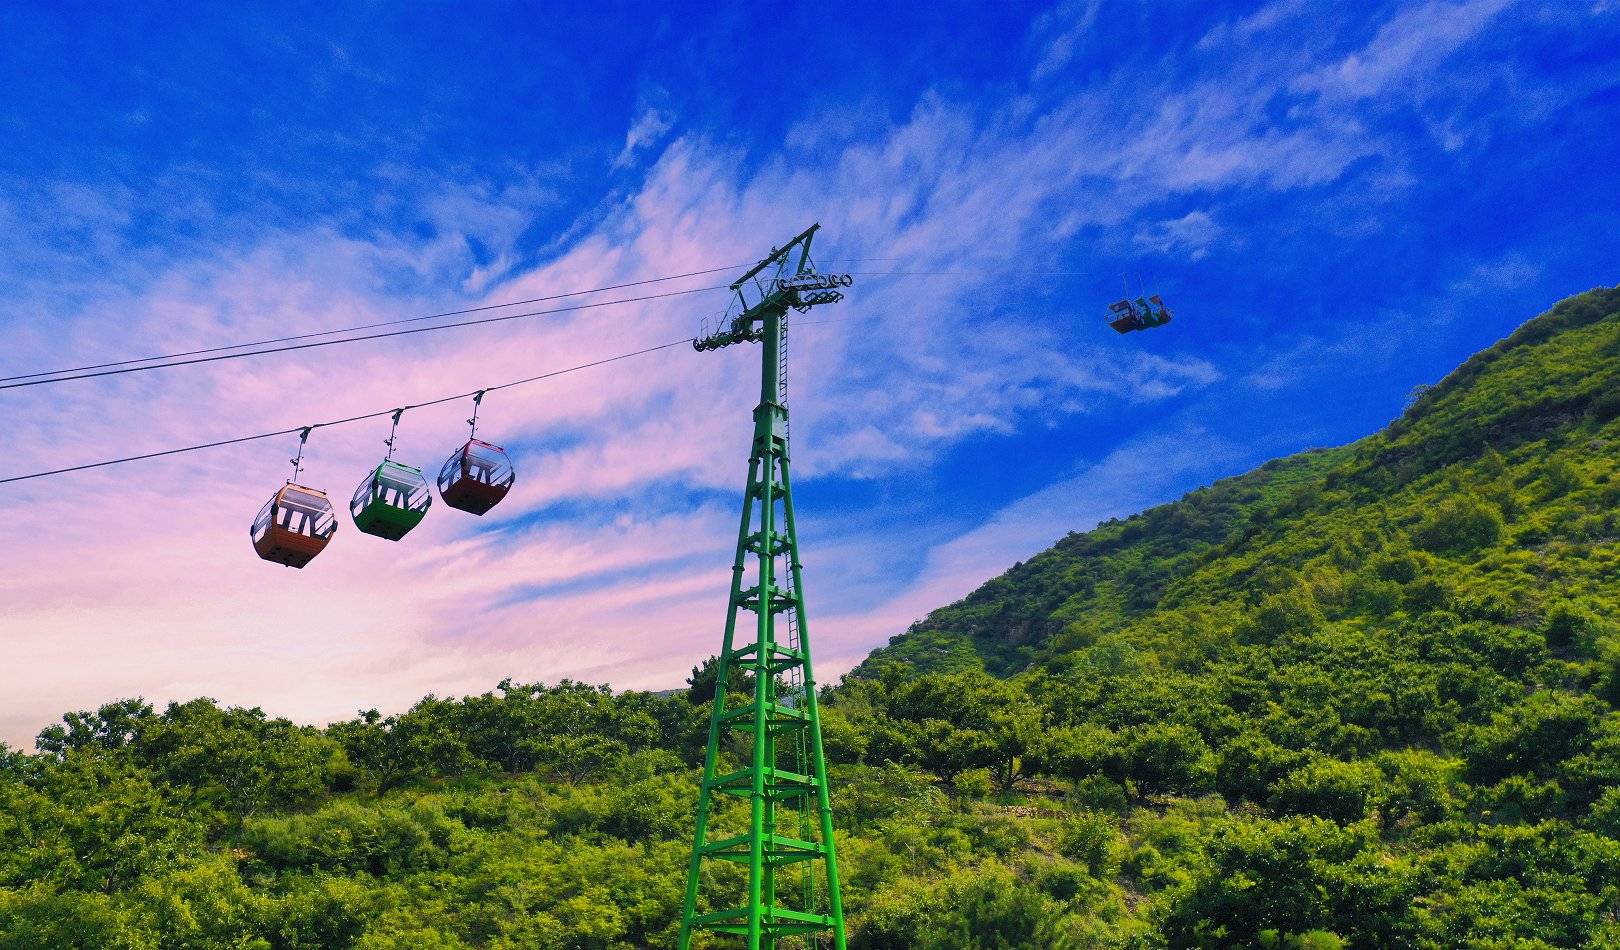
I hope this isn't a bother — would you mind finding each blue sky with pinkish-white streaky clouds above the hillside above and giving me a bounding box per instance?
[0,0,1620,747]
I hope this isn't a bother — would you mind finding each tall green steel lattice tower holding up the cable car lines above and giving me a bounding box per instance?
[679,225,851,950]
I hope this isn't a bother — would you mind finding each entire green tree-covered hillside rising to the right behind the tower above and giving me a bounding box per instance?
[0,290,1620,950]
